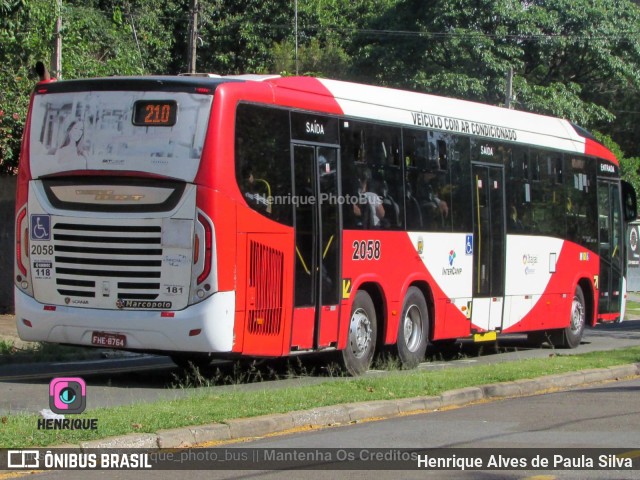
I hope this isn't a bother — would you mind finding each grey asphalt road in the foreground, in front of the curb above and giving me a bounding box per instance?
[7,379,640,480]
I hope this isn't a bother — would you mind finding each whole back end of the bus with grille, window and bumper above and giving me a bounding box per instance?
[15,78,234,353]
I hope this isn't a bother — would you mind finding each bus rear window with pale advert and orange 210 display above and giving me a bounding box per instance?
[30,91,213,181]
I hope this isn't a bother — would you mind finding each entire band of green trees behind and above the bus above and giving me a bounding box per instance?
[0,0,640,191]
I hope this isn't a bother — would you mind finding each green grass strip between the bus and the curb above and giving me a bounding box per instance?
[0,347,640,448]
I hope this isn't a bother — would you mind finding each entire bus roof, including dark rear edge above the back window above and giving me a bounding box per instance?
[36,74,618,164]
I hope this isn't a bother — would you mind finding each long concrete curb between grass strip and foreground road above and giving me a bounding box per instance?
[55,363,640,450]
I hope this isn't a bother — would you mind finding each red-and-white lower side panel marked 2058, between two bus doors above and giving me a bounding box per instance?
[338,230,471,348]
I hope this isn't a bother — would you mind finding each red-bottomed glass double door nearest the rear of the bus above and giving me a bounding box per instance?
[291,144,341,351]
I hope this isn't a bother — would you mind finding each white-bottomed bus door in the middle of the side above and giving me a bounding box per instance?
[471,165,506,333]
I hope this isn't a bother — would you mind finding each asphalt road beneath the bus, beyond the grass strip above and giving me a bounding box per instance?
[0,320,640,414]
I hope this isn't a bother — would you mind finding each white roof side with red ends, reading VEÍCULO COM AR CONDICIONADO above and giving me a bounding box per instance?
[269,77,618,164]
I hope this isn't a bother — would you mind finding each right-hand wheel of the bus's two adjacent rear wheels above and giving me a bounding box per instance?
[396,287,429,368]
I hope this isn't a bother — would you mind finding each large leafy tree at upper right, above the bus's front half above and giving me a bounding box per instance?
[353,0,640,155]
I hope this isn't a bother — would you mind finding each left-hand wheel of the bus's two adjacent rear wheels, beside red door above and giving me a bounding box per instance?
[341,290,378,377]
